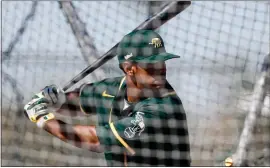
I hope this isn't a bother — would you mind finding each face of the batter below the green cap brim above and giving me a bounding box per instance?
[135,62,166,89]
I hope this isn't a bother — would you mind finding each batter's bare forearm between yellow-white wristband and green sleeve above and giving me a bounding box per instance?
[43,119,102,152]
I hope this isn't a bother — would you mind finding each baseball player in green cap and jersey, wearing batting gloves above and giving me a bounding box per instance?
[24,30,190,166]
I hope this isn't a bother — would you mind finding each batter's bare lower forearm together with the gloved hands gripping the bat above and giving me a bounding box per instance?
[24,86,102,152]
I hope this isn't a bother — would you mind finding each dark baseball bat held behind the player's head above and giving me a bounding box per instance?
[63,1,191,91]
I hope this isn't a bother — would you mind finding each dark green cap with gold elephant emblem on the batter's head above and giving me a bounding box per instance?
[117,30,180,64]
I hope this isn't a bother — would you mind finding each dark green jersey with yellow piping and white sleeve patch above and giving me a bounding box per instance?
[80,77,190,166]
